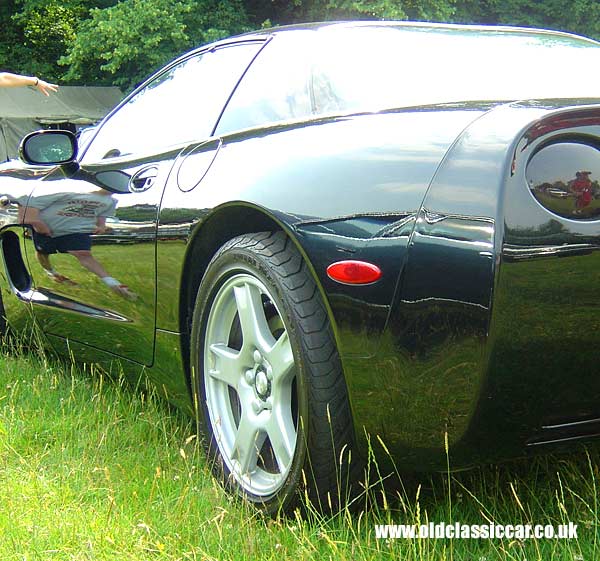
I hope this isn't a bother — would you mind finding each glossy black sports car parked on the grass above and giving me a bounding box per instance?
[0,22,600,512]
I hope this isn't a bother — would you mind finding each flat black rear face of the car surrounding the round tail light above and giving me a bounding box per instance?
[479,106,600,449]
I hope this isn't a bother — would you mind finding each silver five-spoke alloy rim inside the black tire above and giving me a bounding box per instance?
[204,274,298,497]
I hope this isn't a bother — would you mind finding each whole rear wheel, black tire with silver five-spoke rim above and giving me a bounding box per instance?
[191,232,355,514]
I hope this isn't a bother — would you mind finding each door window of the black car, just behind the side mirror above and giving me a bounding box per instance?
[82,42,263,164]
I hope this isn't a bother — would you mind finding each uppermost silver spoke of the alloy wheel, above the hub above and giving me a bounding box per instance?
[234,283,274,352]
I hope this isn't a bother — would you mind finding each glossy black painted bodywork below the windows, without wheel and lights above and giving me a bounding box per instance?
[0,24,600,469]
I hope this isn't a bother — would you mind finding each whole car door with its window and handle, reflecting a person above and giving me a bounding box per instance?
[24,41,262,365]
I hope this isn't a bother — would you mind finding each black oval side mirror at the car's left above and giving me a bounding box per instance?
[19,130,77,166]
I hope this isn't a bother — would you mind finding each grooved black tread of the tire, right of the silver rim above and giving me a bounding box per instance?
[202,231,357,510]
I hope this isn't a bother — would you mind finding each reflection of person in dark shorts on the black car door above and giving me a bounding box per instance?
[20,189,137,300]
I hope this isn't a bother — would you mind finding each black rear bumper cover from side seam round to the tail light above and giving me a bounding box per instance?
[353,104,600,469]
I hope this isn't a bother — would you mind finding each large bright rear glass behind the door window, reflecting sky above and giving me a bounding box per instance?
[217,24,600,134]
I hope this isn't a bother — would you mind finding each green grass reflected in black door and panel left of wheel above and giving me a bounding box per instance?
[26,240,191,358]
